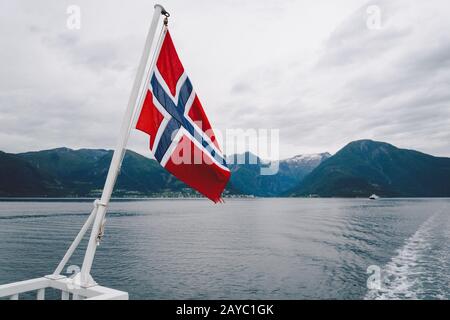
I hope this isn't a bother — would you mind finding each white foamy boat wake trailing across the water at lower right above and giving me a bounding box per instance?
[365,210,450,300]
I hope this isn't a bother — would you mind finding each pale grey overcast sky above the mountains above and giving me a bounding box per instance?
[0,0,450,158]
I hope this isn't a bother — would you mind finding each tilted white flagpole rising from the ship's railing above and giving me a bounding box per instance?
[81,4,168,287]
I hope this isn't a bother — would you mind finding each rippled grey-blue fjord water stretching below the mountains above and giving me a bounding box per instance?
[0,199,450,299]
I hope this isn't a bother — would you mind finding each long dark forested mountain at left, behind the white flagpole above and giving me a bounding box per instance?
[0,148,190,197]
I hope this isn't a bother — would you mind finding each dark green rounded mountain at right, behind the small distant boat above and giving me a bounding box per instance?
[289,140,450,197]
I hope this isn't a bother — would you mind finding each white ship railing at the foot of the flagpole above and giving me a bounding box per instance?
[0,275,128,300]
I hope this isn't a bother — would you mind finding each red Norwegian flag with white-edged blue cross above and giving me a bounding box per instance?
[136,29,231,203]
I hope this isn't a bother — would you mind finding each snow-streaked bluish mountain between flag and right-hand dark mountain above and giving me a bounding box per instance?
[227,152,331,197]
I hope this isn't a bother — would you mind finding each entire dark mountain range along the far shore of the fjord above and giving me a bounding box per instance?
[0,140,450,197]
